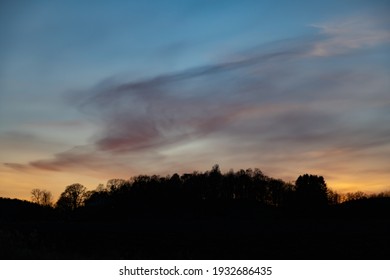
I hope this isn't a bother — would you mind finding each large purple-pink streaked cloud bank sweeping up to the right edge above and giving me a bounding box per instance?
[8,14,390,188]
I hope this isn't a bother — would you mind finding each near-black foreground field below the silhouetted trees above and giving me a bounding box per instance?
[0,200,390,259]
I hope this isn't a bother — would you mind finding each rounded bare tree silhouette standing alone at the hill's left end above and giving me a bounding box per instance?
[57,184,87,210]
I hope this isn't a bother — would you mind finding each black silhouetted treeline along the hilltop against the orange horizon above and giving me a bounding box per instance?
[26,165,389,218]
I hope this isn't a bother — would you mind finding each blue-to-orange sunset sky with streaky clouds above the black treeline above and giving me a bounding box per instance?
[0,0,390,199]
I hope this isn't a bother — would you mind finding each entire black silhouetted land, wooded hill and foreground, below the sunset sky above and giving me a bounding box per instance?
[0,165,390,259]
